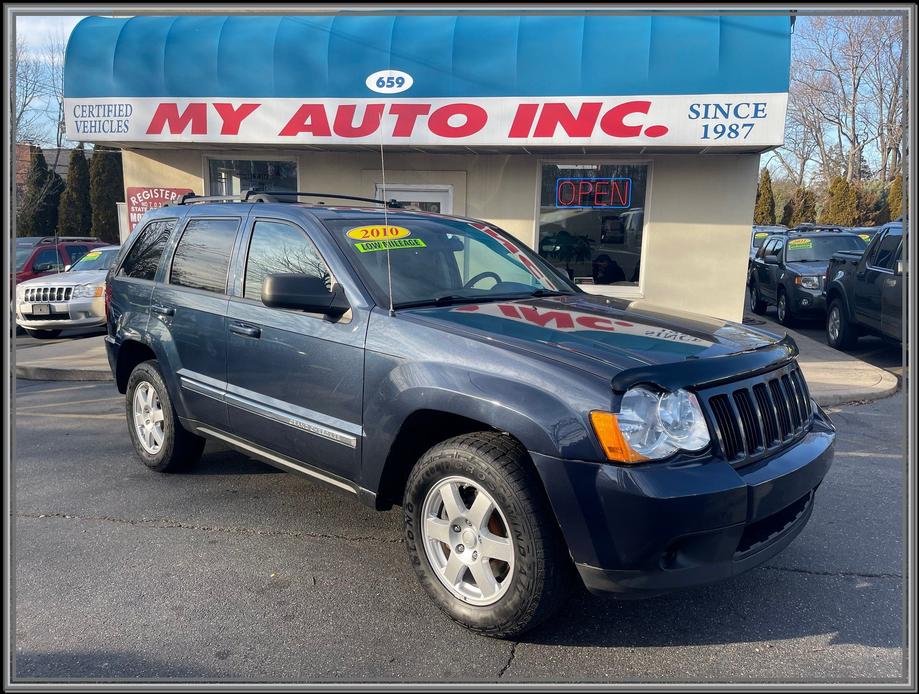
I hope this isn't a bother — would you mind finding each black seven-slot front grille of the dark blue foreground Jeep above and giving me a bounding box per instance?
[700,364,812,465]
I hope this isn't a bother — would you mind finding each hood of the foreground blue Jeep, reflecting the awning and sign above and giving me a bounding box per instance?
[400,294,780,380]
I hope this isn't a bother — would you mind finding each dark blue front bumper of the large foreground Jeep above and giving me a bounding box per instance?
[531,410,835,597]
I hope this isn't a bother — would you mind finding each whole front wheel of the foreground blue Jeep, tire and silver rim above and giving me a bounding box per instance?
[403,432,572,638]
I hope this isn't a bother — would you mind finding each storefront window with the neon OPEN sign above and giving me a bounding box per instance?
[539,163,648,286]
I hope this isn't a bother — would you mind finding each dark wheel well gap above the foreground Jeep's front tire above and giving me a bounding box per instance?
[376,410,516,510]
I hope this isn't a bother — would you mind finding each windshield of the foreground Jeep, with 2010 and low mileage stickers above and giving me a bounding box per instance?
[323,213,578,307]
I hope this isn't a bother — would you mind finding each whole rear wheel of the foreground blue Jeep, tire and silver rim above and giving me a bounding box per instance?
[125,359,205,472]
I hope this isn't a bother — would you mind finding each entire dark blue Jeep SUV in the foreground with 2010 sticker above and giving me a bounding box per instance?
[106,193,835,637]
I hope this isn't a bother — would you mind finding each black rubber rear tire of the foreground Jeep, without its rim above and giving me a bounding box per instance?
[125,359,205,472]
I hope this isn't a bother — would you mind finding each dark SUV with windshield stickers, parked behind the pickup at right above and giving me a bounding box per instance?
[747,230,865,325]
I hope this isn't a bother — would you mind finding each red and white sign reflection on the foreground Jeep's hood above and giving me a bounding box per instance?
[453,303,714,347]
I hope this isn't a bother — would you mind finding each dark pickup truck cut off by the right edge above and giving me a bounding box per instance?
[825,221,903,350]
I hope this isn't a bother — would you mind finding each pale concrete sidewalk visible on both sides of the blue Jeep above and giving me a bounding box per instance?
[16,324,899,406]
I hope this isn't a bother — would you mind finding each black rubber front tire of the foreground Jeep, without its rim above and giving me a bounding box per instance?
[402,432,574,638]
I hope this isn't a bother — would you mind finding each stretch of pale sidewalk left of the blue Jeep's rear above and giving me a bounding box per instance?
[16,335,112,381]
